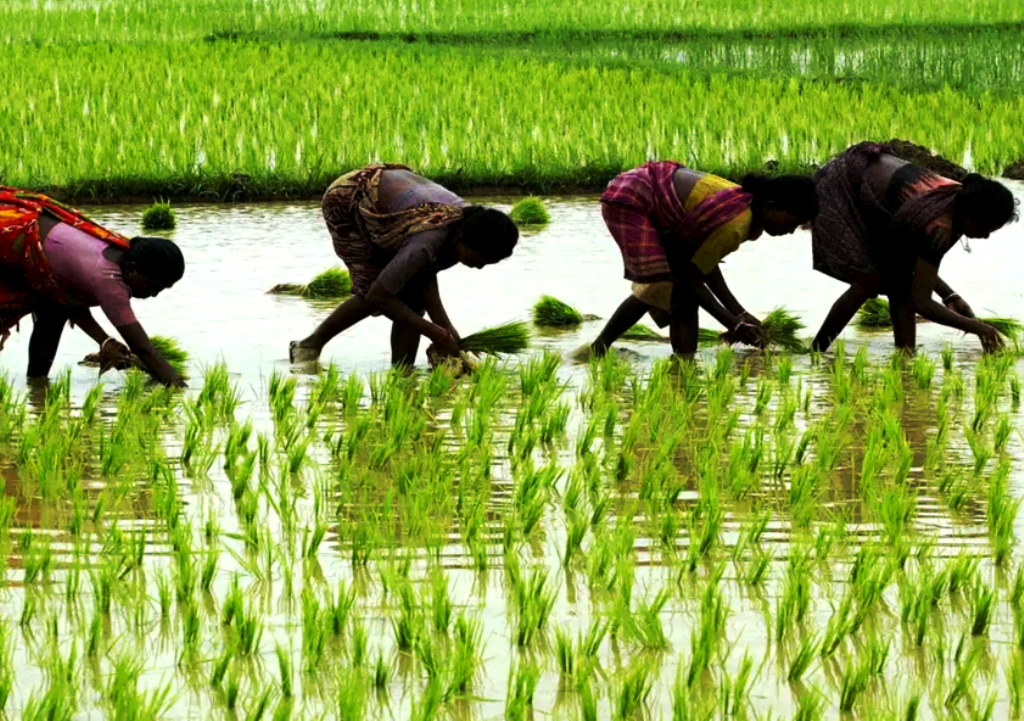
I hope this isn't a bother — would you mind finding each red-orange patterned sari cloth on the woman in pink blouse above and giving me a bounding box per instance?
[0,185,129,337]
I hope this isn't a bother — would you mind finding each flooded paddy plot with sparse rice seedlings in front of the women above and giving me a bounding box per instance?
[0,186,1024,719]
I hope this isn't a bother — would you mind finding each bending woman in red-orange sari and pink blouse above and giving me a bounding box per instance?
[0,186,185,386]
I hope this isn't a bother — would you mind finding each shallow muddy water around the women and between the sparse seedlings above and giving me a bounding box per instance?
[0,185,1024,719]
